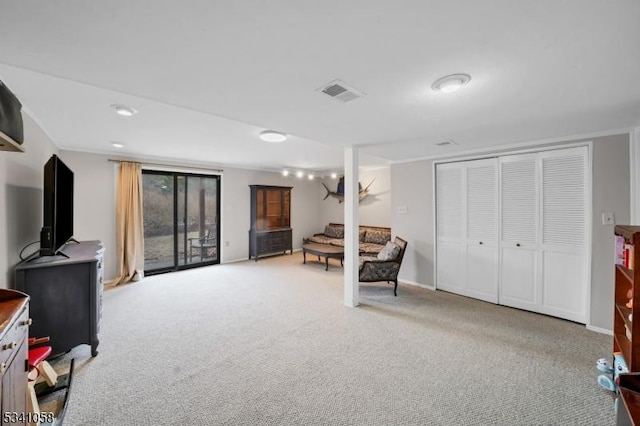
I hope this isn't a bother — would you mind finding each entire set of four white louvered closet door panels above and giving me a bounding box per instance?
[436,146,590,323]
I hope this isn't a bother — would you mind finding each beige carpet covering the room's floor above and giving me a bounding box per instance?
[45,253,615,426]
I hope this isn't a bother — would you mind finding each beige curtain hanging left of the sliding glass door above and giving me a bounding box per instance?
[114,161,144,285]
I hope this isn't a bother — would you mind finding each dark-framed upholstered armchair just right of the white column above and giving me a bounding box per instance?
[359,237,407,296]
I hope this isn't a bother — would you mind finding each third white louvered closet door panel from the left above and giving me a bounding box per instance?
[499,154,539,311]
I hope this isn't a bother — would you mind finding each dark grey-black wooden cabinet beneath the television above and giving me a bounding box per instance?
[15,241,104,356]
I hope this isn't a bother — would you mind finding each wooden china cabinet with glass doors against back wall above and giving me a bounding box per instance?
[249,185,293,261]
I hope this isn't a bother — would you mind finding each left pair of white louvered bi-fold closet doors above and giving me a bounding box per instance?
[436,158,498,303]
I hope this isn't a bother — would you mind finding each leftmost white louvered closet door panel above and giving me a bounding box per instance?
[436,163,465,293]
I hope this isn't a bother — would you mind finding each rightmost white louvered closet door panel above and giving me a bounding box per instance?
[540,147,590,323]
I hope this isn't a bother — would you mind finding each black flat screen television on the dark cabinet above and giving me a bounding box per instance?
[40,155,73,256]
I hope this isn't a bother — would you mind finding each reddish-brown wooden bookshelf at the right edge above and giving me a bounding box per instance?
[613,225,640,372]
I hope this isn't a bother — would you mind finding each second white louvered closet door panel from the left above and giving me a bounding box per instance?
[464,158,498,303]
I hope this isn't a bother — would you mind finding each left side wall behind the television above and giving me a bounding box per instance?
[0,113,58,288]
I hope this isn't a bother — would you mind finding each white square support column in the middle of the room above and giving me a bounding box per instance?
[344,146,360,307]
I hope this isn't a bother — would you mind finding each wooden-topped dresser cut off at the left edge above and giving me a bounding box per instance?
[0,289,31,425]
